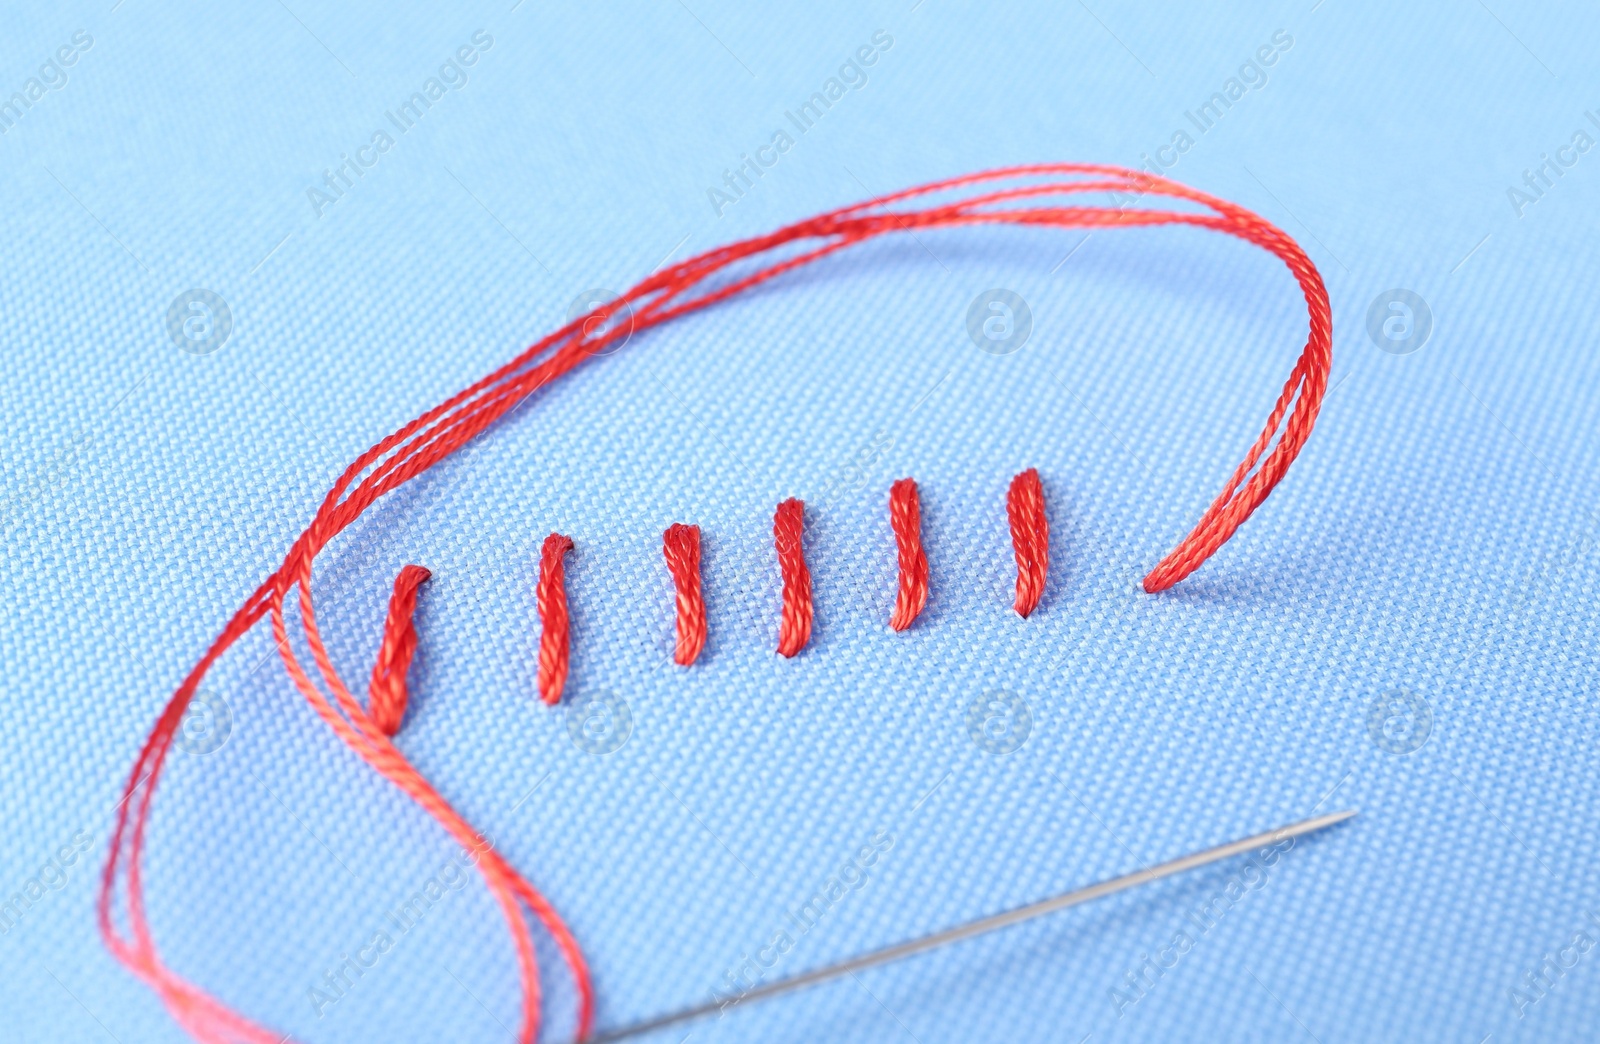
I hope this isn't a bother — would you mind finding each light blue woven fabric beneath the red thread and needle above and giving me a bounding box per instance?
[0,0,1600,1044]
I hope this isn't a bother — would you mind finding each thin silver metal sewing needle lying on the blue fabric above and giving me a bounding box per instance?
[589,810,1355,1044]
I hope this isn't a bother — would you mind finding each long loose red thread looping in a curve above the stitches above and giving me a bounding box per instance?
[96,163,1333,1044]
